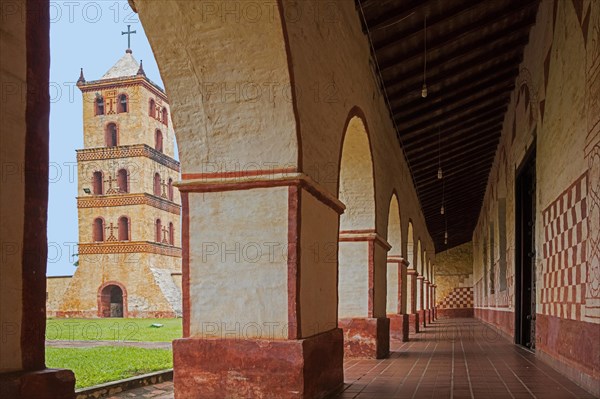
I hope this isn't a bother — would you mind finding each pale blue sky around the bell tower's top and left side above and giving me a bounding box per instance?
[48,0,163,276]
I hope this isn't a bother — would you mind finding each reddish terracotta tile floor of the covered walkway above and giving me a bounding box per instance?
[113,319,594,399]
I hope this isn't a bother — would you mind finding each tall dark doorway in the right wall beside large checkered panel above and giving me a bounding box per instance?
[515,148,536,350]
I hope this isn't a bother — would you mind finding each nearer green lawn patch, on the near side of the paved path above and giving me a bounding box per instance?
[46,346,173,388]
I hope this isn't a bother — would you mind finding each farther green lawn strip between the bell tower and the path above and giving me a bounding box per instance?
[46,318,182,342]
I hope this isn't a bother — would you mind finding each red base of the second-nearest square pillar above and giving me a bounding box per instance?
[338,317,390,359]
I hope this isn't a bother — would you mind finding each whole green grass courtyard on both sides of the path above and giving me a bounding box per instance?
[46,318,182,388]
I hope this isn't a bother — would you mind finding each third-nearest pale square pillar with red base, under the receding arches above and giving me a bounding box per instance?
[387,256,409,342]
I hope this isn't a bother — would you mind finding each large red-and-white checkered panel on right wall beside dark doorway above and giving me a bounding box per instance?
[540,174,588,320]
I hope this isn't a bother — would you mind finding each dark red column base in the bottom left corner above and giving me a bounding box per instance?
[0,369,75,399]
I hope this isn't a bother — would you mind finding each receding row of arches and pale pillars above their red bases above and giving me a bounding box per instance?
[338,110,433,334]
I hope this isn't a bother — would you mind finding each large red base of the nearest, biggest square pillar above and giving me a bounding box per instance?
[173,328,344,399]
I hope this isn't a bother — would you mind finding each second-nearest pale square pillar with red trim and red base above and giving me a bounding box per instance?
[338,230,391,359]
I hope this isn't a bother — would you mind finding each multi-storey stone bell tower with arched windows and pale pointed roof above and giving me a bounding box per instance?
[56,45,181,317]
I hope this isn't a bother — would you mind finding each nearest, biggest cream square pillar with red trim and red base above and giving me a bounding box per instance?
[173,173,343,399]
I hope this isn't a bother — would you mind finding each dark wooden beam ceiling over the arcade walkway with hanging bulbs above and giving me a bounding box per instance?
[355,0,539,251]
